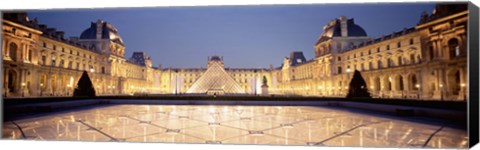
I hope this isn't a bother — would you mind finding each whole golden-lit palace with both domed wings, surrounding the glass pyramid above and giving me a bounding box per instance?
[2,4,468,100]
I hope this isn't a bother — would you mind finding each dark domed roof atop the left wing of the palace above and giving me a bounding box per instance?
[80,20,124,46]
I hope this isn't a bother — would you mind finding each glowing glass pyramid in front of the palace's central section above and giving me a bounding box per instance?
[187,63,245,94]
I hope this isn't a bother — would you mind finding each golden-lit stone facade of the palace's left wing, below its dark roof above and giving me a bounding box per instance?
[2,13,161,97]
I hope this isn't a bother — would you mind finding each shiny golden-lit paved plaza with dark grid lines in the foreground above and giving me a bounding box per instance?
[2,105,468,148]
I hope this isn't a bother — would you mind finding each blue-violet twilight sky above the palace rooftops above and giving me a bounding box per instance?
[28,3,435,68]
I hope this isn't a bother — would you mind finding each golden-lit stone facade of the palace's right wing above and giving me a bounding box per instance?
[270,5,468,100]
